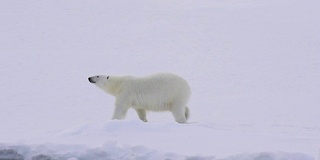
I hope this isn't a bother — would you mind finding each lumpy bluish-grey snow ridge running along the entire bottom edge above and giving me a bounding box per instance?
[0,143,314,160]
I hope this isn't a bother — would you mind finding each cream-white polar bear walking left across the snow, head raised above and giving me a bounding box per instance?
[88,73,191,123]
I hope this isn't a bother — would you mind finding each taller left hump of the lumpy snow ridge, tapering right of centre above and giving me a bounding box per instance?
[0,143,208,160]
